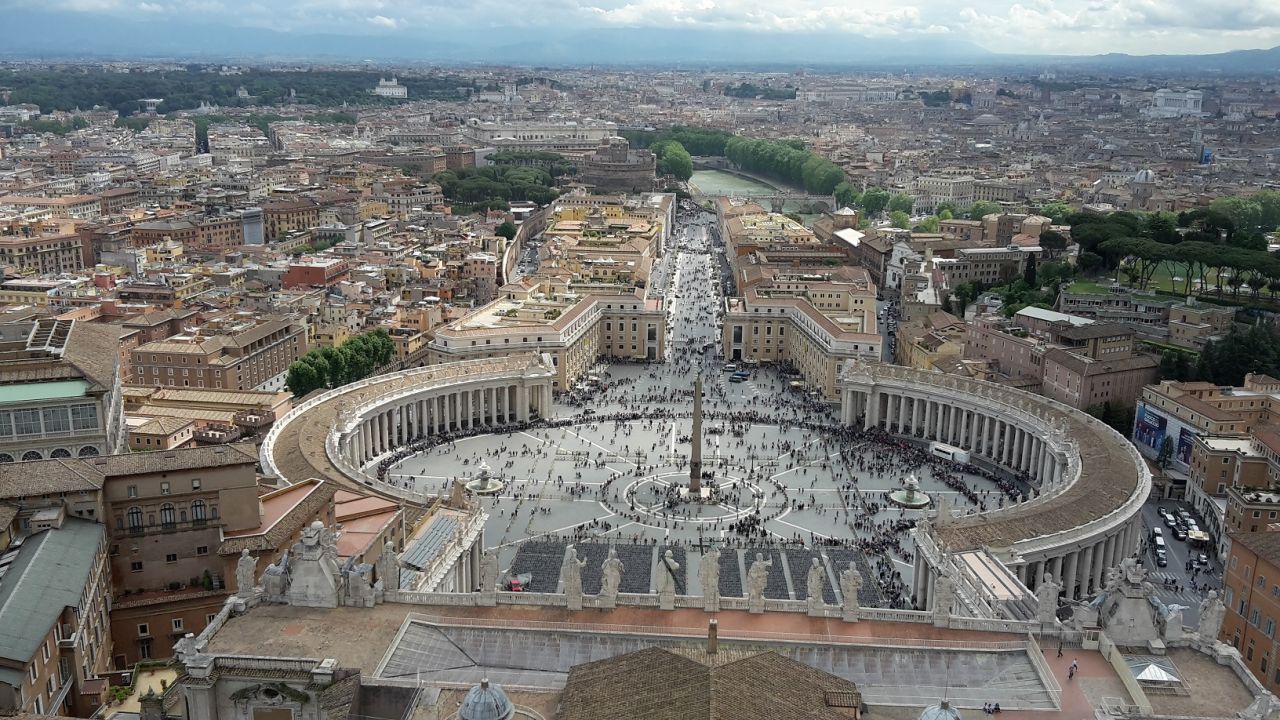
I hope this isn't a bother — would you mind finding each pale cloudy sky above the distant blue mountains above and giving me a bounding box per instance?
[15,0,1280,55]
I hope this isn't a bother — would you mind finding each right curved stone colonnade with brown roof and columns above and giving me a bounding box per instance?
[840,360,1151,607]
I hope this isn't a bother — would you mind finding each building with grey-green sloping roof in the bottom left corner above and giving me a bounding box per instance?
[0,507,111,717]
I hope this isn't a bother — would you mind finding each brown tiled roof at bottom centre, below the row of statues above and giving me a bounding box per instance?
[557,647,861,720]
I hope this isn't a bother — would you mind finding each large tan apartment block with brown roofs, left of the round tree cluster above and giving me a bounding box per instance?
[129,314,307,391]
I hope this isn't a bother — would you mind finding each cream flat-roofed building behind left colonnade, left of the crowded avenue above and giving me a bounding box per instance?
[424,279,667,391]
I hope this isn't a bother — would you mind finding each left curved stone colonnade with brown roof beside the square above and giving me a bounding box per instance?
[261,354,556,503]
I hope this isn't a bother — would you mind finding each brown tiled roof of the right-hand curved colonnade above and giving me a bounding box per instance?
[841,361,1149,551]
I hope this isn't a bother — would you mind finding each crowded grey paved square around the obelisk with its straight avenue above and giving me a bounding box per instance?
[387,207,1023,606]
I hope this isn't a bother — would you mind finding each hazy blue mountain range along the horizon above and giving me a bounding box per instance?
[0,12,1280,73]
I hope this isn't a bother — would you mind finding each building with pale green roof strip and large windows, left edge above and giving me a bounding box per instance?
[0,318,124,462]
